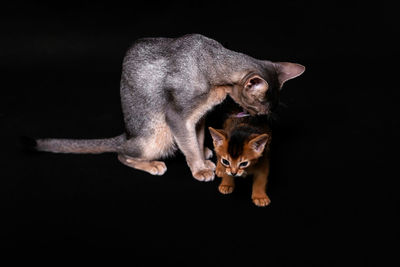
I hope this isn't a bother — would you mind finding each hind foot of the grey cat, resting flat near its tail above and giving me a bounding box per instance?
[118,154,167,175]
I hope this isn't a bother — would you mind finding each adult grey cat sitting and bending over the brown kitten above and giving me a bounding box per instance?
[36,34,304,181]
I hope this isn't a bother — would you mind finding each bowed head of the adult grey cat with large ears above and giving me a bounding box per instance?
[231,61,305,115]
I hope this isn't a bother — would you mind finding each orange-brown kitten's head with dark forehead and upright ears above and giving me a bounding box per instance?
[209,127,271,176]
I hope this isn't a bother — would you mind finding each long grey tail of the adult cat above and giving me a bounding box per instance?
[30,134,126,154]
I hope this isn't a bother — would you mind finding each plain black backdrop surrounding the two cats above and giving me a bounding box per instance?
[0,1,399,266]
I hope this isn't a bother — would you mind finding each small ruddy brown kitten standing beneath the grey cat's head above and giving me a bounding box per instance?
[209,114,271,207]
